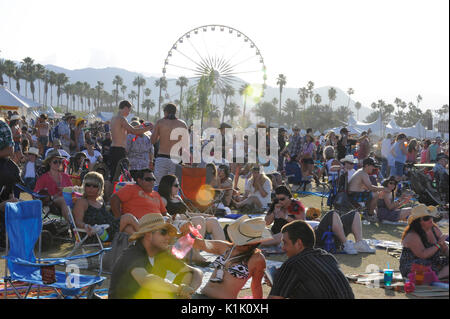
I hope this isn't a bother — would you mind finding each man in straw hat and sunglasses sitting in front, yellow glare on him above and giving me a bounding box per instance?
[108,214,203,299]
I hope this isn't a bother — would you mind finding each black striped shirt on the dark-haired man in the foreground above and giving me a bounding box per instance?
[270,248,355,299]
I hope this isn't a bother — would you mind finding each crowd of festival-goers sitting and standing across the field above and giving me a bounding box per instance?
[0,101,449,299]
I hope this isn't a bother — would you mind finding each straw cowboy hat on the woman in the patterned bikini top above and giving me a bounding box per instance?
[227,215,272,246]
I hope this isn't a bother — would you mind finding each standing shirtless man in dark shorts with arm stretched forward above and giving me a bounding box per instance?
[109,100,153,182]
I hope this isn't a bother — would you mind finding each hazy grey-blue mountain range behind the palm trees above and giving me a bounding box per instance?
[7,64,373,121]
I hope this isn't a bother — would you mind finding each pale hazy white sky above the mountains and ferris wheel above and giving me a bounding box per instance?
[0,0,449,108]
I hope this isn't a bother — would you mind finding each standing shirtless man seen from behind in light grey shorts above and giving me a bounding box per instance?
[151,103,187,185]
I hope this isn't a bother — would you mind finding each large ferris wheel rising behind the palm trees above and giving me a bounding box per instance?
[162,24,267,110]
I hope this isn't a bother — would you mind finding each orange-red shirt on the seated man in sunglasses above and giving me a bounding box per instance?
[116,184,167,219]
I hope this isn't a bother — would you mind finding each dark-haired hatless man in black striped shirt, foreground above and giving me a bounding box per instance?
[269,220,355,299]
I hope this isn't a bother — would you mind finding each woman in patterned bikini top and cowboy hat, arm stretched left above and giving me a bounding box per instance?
[180,215,271,299]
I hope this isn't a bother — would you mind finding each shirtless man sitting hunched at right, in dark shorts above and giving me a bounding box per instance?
[348,157,384,216]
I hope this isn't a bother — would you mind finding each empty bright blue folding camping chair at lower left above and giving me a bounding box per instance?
[3,200,106,299]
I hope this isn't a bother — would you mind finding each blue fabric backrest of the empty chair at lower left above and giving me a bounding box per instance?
[5,200,42,274]
